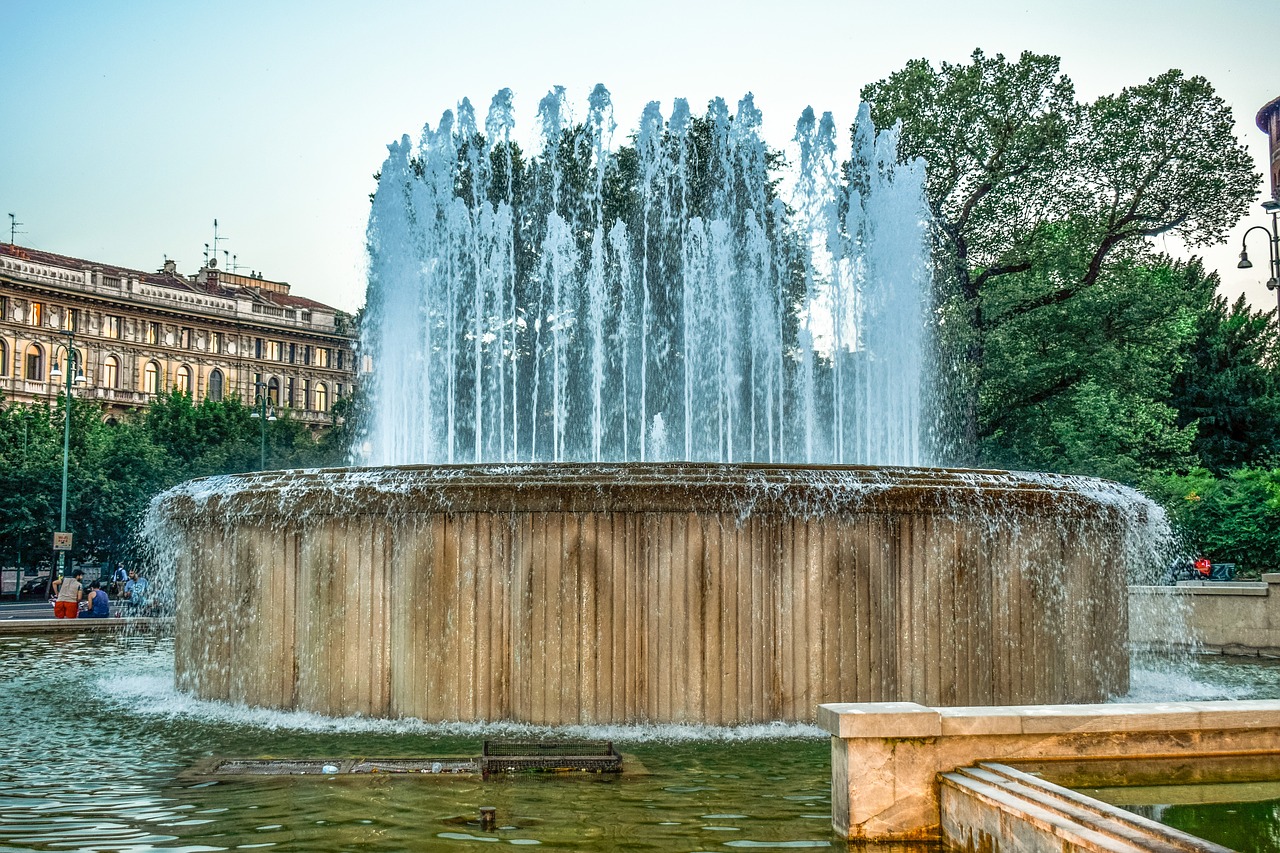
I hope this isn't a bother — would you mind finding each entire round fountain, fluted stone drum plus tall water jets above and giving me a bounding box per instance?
[150,87,1160,725]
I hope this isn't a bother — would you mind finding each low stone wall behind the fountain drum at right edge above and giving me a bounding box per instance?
[1129,573,1280,657]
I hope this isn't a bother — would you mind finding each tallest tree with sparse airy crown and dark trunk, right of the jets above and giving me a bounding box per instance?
[861,50,1261,461]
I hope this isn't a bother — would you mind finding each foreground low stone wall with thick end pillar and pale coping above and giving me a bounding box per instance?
[818,699,1280,841]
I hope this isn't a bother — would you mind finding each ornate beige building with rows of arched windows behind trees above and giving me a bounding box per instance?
[0,243,356,427]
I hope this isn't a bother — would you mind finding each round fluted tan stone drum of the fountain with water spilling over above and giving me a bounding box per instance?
[157,465,1132,724]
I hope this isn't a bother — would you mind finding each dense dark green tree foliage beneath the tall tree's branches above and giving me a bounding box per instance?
[979,249,1212,483]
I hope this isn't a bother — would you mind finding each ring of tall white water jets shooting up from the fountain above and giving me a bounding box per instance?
[361,86,932,465]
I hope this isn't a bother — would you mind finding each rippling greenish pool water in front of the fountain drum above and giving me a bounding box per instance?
[0,635,844,853]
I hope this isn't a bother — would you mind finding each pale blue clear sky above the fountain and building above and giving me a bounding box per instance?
[0,0,1280,310]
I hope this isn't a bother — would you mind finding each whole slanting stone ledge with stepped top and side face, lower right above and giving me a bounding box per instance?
[941,763,1230,853]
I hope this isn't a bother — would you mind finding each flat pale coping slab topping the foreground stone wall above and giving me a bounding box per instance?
[818,699,1280,740]
